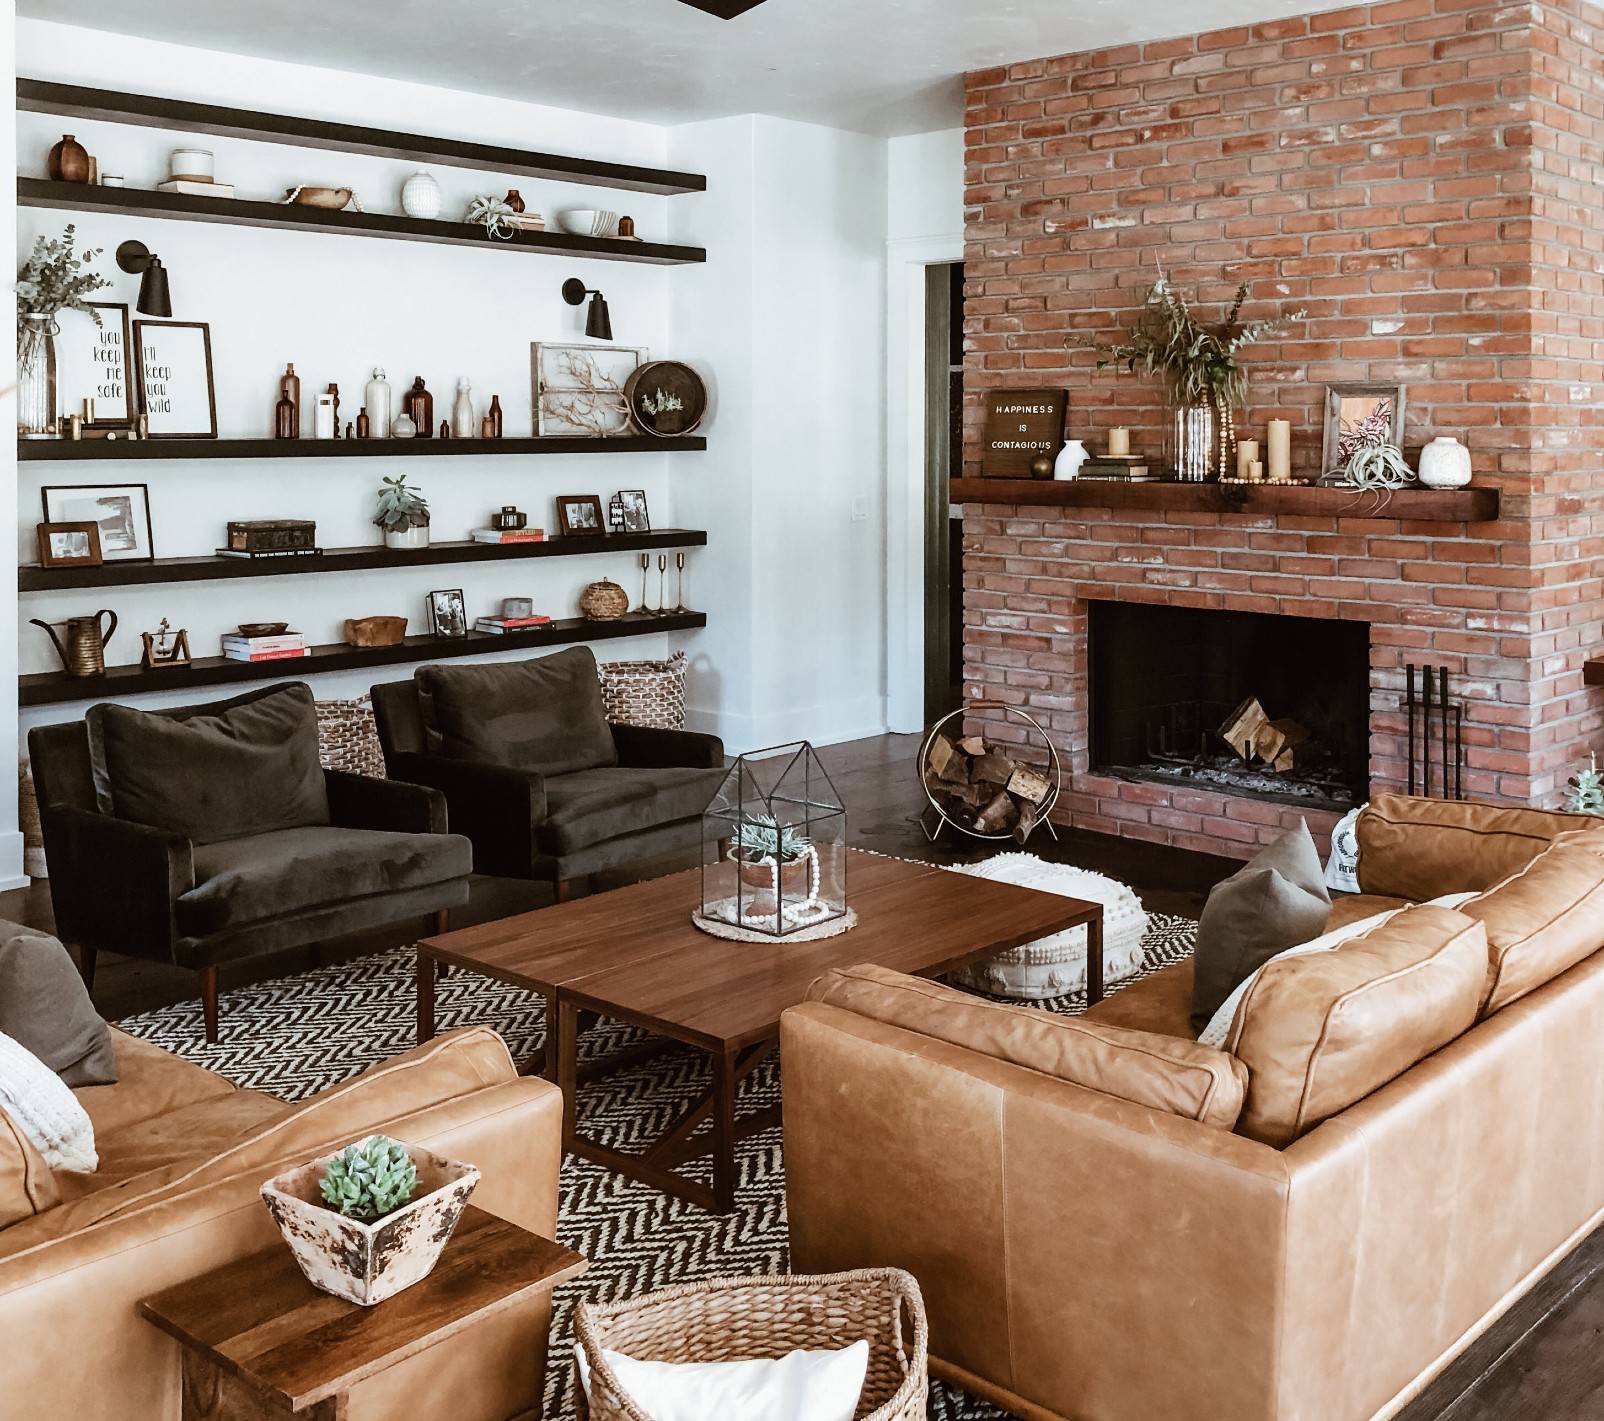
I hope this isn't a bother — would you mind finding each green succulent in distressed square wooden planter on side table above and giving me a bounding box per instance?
[261,1136,480,1307]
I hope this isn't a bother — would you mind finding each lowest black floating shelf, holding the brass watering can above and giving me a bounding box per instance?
[18,611,707,706]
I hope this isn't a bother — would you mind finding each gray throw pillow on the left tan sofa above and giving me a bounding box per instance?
[0,921,117,1086]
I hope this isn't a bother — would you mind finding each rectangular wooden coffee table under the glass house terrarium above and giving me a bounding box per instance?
[417,850,1104,1213]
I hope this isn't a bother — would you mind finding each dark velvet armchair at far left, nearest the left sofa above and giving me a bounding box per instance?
[27,686,473,1041]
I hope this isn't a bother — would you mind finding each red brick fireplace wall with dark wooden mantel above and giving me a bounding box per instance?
[954,0,1604,855]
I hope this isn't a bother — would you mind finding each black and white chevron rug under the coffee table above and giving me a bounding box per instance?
[119,914,1197,1421]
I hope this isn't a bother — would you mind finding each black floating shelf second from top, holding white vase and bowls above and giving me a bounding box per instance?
[16,178,707,266]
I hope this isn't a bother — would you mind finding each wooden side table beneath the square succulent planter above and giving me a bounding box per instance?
[140,1204,585,1421]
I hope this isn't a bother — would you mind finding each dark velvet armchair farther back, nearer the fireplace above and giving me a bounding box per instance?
[372,646,723,901]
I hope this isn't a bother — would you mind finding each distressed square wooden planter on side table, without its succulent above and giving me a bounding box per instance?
[261,1137,480,1307]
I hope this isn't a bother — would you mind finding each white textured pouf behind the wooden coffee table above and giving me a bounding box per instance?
[950,853,1147,1001]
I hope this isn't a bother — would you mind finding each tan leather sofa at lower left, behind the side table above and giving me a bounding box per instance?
[0,1028,561,1421]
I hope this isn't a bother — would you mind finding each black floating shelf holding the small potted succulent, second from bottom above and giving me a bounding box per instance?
[16,528,707,592]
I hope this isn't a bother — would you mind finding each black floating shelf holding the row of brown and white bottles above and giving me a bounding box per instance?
[16,435,707,464]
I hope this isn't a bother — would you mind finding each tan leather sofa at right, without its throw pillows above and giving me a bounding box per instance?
[781,797,1604,1421]
